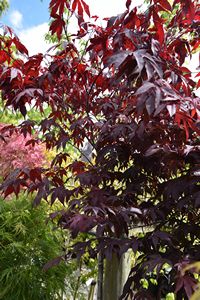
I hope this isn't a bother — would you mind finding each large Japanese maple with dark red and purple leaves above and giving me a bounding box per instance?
[0,0,200,299]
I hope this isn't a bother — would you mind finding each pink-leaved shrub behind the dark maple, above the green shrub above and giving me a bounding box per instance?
[0,124,45,177]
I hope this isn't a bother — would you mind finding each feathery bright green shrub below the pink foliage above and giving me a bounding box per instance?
[0,198,69,300]
